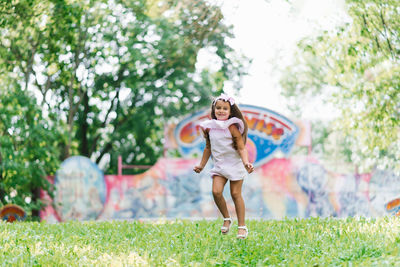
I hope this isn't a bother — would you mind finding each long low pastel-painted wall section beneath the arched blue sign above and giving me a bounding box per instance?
[41,156,400,222]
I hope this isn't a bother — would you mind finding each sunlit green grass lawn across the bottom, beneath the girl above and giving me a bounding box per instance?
[0,217,400,266]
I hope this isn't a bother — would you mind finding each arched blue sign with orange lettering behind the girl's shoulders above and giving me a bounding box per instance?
[175,105,299,167]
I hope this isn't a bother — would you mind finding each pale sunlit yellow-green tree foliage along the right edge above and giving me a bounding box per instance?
[281,0,400,174]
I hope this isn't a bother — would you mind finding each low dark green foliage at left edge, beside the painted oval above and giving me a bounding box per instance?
[0,83,61,217]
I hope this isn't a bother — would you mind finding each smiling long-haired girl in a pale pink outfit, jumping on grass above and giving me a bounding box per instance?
[193,94,254,239]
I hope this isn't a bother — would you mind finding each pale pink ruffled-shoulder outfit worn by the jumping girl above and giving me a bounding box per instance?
[200,117,247,181]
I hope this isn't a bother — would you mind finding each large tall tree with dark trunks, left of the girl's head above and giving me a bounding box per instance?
[0,0,247,176]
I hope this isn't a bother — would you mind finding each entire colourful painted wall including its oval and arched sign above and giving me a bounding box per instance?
[41,105,400,222]
